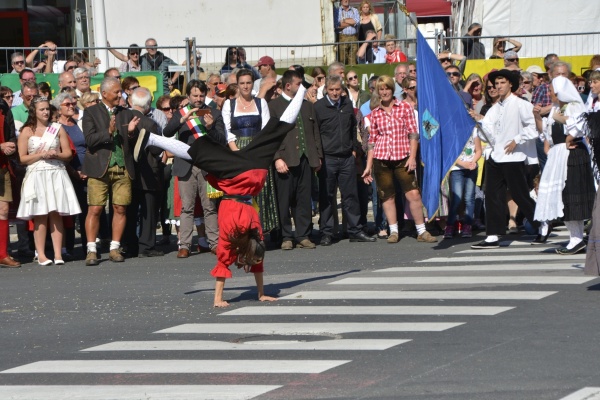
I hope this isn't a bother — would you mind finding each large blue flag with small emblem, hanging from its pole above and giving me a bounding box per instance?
[417,29,475,218]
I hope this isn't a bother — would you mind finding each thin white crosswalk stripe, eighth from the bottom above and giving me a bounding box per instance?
[373,264,583,273]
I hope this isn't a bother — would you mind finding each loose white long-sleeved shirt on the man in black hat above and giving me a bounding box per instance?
[478,93,538,163]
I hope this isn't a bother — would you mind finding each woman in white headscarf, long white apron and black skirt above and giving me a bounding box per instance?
[532,76,595,255]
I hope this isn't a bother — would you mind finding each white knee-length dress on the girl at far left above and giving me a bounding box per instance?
[17,135,81,220]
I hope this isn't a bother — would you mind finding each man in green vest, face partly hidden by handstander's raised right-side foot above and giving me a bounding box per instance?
[269,71,323,250]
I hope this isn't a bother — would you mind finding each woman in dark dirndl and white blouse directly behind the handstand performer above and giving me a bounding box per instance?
[223,69,279,232]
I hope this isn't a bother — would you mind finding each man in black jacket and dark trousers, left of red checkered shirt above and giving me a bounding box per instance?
[314,75,376,246]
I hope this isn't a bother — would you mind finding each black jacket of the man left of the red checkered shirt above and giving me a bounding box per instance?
[314,96,360,157]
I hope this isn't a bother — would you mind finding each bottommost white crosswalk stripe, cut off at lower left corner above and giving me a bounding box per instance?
[0,385,282,400]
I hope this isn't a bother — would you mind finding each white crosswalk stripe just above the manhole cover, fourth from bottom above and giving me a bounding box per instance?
[155,322,464,336]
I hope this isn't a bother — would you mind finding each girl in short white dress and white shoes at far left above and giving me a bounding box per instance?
[17,96,81,265]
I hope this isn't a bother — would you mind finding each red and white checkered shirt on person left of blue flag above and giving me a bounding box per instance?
[369,99,418,161]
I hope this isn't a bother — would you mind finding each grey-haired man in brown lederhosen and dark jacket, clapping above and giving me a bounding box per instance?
[81,78,140,265]
